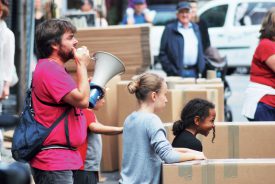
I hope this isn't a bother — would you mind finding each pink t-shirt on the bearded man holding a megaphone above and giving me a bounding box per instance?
[30,59,87,171]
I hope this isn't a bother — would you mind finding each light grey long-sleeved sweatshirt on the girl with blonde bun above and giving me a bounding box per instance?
[120,112,180,184]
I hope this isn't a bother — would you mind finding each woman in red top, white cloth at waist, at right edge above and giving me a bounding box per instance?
[242,7,275,121]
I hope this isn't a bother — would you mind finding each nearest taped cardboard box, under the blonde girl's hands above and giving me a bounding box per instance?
[162,159,275,184]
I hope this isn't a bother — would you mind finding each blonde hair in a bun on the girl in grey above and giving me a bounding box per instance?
[127,73,164,101]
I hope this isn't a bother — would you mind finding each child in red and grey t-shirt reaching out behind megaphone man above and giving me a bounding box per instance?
[74,87,123,184]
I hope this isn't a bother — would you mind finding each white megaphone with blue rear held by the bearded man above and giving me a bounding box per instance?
[89,51,125,108]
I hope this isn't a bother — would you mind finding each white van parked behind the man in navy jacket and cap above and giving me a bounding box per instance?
[150,0,275,71]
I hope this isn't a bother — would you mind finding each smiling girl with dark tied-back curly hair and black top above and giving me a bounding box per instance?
[172,98,216,151]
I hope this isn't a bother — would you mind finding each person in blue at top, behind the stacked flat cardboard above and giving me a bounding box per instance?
[122,0,153,25]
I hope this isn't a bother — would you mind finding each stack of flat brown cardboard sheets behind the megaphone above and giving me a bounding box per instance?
[66,24,151,79]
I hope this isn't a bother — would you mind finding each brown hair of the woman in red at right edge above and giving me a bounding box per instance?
[260,7,275,40]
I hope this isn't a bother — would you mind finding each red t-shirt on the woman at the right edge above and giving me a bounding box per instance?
[250,39,275,107]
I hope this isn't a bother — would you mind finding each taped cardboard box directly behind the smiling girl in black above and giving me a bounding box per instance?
[164,122,275,159]
